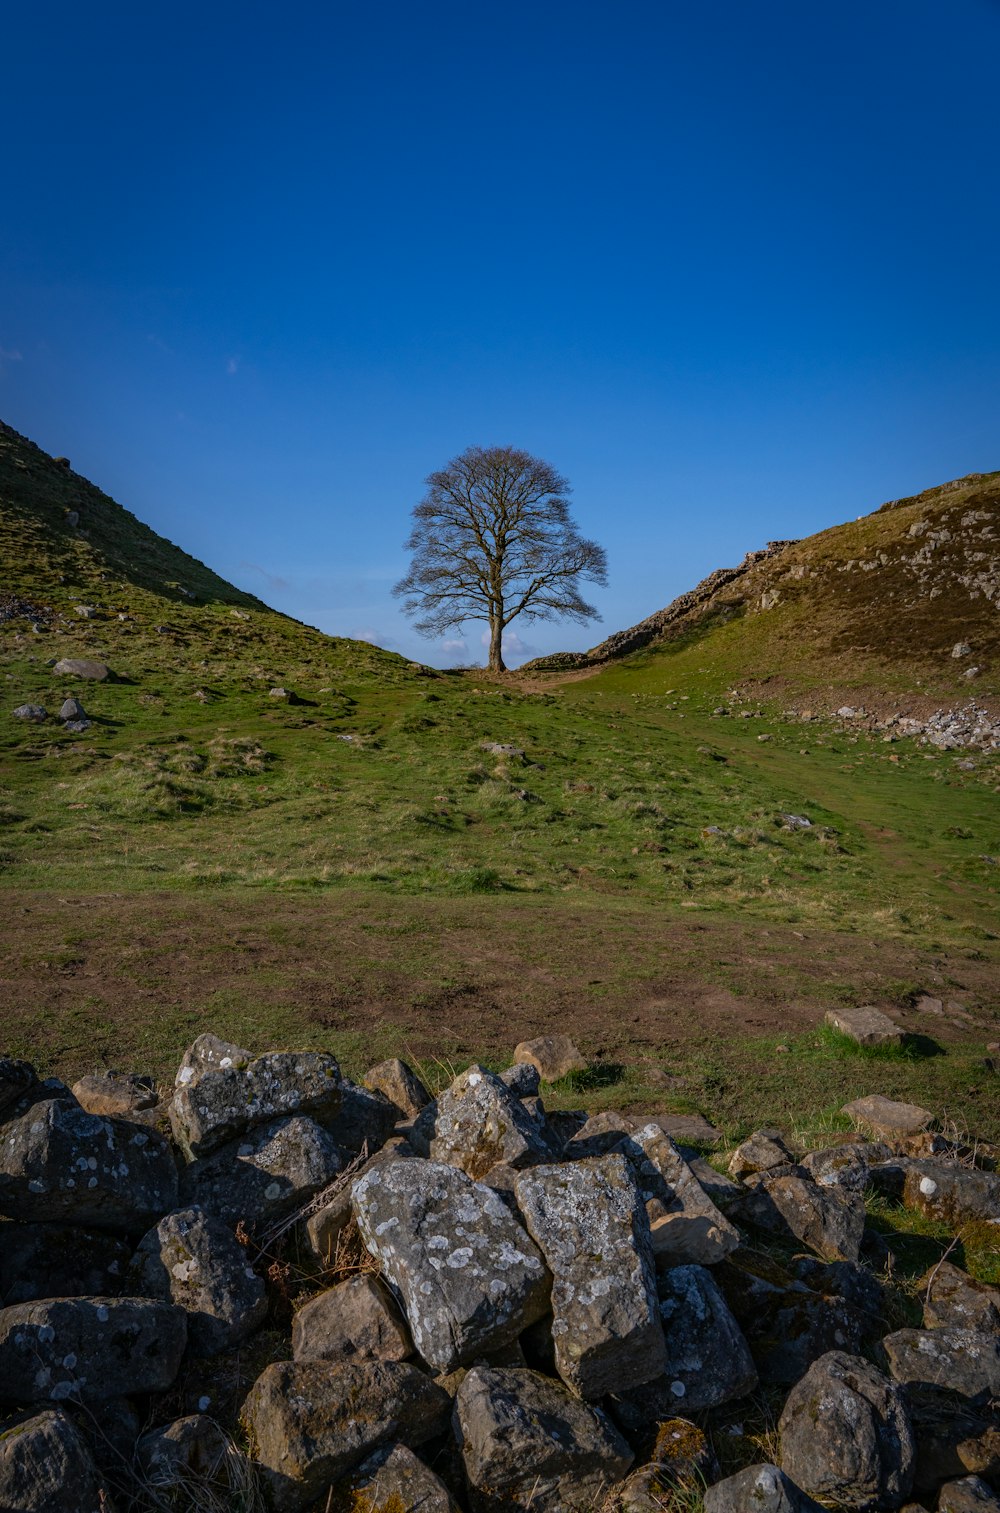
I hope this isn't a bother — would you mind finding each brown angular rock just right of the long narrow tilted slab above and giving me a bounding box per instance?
[738,1173,865,1260]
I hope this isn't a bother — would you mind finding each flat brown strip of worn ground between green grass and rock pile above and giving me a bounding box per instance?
[0,891,1000,1077]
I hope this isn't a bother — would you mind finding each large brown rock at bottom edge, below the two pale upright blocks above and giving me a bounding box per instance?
[454,1366,632,1513]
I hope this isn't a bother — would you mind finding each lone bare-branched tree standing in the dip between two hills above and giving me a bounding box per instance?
[393,446,608,672]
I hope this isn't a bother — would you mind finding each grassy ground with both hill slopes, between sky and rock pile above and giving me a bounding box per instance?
[0,414,1000,1130]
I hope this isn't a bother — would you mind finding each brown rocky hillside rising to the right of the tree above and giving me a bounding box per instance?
[530,474,1000,693]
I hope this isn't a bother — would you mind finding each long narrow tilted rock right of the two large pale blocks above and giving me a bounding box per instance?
[614,1123,740,1266]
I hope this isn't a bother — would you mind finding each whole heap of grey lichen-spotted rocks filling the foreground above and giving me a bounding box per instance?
[0,1035,1000,1513]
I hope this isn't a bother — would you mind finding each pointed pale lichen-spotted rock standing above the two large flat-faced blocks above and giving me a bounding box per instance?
[430,1065,551,1180]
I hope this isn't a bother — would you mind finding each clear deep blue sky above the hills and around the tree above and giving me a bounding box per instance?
[0,0,1000,663]
